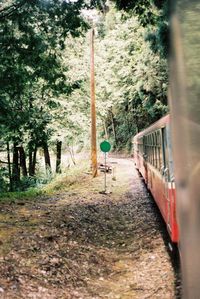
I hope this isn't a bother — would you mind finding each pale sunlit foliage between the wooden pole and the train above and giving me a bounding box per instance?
[96,10,168,149]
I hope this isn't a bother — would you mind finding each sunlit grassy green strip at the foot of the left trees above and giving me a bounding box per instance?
[0,161,89,202]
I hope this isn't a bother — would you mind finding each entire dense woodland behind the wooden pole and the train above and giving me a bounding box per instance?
[0,0,169,192]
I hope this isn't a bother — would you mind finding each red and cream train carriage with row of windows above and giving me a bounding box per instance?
[133,115,178,243]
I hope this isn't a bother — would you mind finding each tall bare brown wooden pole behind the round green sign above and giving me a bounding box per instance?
[90,29,97,178]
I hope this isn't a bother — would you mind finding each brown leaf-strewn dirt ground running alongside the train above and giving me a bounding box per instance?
[0,159,180,299]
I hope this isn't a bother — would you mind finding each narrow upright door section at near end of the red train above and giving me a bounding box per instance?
[162,127,171,231]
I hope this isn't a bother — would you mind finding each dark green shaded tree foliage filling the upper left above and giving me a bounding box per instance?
[0,0,88,189]
